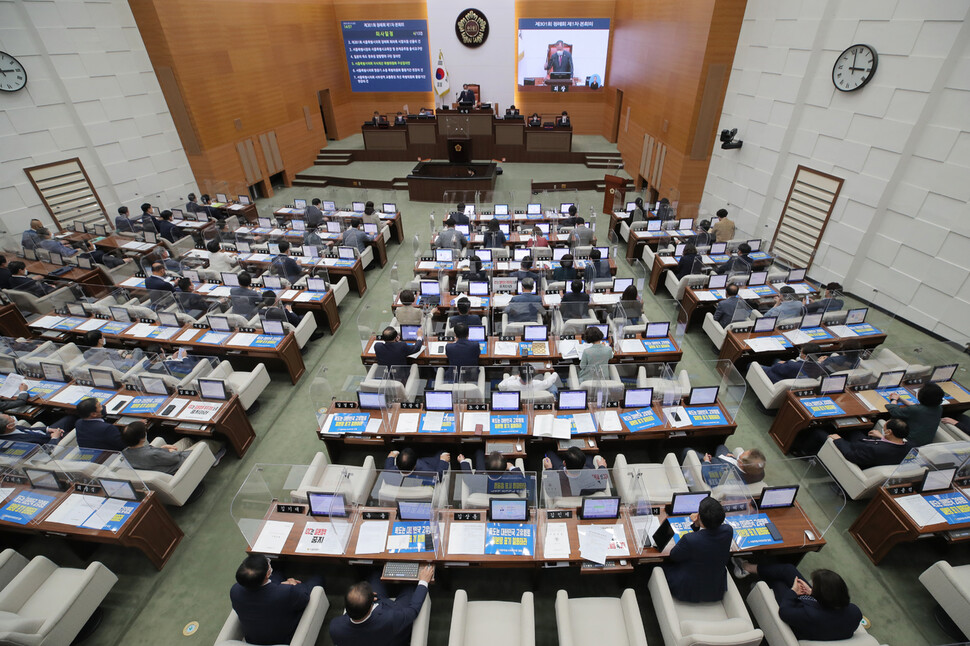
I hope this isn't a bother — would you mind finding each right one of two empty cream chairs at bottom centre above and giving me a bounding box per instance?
[556,588,647,646]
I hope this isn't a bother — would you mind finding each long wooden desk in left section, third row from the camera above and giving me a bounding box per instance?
[28,316,306,384]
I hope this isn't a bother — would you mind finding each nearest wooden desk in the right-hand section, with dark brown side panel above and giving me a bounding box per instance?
[849,487,970,565]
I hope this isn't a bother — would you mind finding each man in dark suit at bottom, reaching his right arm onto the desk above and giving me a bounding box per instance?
[330,565,434,646]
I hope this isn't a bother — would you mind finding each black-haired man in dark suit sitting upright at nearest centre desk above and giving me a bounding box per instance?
[663,498,734,603]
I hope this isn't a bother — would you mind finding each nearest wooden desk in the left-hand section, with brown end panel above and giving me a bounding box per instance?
[0,485,184,570]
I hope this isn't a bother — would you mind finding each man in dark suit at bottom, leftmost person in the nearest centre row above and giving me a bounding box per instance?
[229,554,323,644]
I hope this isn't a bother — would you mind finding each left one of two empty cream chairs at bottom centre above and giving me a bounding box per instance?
[448,590,536,646]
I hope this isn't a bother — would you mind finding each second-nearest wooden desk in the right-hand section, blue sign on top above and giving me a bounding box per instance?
[768,381,970,453]
